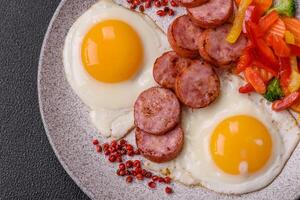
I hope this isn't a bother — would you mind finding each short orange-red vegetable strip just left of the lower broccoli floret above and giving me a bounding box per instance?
[245,67,266,94]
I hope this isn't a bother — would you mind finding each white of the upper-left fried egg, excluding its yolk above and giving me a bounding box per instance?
[63,0,169,138]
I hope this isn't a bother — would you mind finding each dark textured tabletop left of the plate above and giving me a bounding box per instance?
[0,0,88,200]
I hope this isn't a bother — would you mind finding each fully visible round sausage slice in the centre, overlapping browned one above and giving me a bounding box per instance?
[175,60,220,108]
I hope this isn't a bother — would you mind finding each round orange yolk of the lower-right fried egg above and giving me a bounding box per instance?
[210,115,272,175]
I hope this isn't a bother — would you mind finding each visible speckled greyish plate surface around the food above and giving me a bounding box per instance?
[38,0,300,200]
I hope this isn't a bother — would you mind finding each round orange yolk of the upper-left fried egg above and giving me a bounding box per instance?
[81,20,143,83]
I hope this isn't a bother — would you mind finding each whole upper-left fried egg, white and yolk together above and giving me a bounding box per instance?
[63,0,169,139]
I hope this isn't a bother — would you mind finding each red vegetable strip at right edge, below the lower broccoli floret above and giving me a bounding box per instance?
[272,92,300,112]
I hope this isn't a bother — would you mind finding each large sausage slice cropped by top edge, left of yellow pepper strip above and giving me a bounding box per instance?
[187,0,233,28]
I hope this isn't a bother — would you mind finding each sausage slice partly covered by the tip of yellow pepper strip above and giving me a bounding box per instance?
[204,24,247,67]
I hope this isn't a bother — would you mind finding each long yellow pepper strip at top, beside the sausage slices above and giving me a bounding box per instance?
[226,0,252,44]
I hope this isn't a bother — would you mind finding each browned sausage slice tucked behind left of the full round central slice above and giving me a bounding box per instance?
[153,51,191,89]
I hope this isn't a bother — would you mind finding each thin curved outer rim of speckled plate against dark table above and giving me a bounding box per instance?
[37,0,93,199]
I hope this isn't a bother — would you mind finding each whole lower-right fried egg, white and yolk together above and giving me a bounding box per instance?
[146,73,300,194]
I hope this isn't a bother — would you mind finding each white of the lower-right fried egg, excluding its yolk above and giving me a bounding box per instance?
[146,73,300,194]
